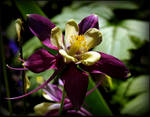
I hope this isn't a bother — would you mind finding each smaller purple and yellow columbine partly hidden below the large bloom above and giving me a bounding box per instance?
[34,80,92,116]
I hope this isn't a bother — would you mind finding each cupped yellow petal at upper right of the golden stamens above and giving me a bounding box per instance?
[84,28,102,50]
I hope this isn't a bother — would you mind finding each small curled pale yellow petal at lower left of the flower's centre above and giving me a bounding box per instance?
[59,49,78,63]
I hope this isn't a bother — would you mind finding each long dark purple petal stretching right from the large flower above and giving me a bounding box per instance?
[81,52,130,78]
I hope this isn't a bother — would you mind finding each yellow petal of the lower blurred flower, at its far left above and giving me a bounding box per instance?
[34,102,51,115]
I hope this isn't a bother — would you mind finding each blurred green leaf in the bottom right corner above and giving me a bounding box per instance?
[121,92,149,116]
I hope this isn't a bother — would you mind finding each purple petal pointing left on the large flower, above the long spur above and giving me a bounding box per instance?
[24,49,56,73]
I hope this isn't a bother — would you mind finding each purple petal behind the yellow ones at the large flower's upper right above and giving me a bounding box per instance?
[79,14,99,35]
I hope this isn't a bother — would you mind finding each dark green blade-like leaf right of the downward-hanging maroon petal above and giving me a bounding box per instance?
[85,78,112,116]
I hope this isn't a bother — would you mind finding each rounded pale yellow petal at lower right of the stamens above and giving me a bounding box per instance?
[80,51,101,66]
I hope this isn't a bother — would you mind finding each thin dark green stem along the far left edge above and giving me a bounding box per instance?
[0,29,12,115]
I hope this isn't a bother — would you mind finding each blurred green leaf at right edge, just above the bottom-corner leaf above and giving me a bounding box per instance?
[125,76,149,96]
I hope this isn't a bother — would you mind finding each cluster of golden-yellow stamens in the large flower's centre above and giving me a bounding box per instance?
[68,35,88,56]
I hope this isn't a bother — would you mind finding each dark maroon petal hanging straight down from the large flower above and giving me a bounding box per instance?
[61,64,88,108]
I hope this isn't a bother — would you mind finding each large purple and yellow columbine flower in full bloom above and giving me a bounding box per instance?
[7,14,129,108]
